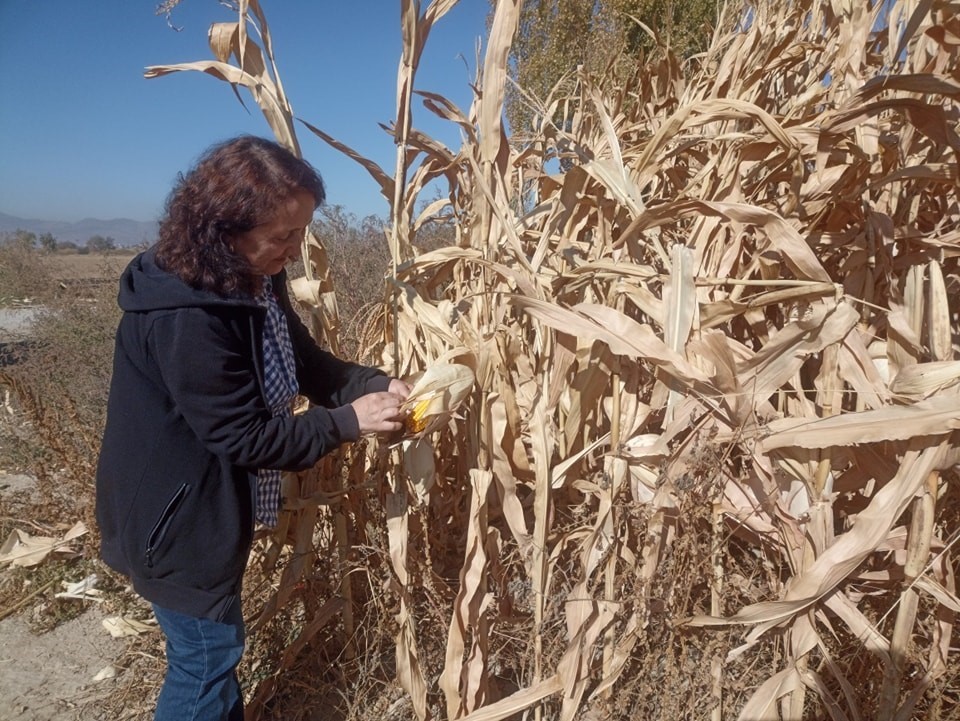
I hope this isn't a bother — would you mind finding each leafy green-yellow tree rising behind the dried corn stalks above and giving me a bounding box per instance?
[506,0,718,142]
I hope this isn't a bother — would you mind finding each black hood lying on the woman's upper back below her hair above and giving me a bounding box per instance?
[117,246,256,312]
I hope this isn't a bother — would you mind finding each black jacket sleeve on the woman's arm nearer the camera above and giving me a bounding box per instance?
[147,308,359,471]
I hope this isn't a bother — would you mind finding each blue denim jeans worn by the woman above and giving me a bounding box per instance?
[153,598,244,721]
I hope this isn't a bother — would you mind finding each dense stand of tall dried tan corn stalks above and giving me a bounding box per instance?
[147,0,960,721]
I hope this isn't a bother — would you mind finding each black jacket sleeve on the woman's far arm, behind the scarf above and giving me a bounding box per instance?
[274,275,390,408]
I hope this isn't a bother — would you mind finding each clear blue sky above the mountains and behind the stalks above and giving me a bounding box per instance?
[0,0,489,221]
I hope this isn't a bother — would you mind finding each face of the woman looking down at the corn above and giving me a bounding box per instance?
[234,190,314,275]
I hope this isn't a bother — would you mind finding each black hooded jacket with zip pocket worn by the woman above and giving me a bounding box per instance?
[97,249,390,619]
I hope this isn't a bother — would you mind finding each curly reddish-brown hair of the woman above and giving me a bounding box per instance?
[157,135,326,297]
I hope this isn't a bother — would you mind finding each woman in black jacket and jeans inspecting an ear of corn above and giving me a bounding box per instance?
[97,137,410,721]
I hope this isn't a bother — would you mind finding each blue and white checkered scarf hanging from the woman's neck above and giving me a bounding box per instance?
[257,277,300,527]
